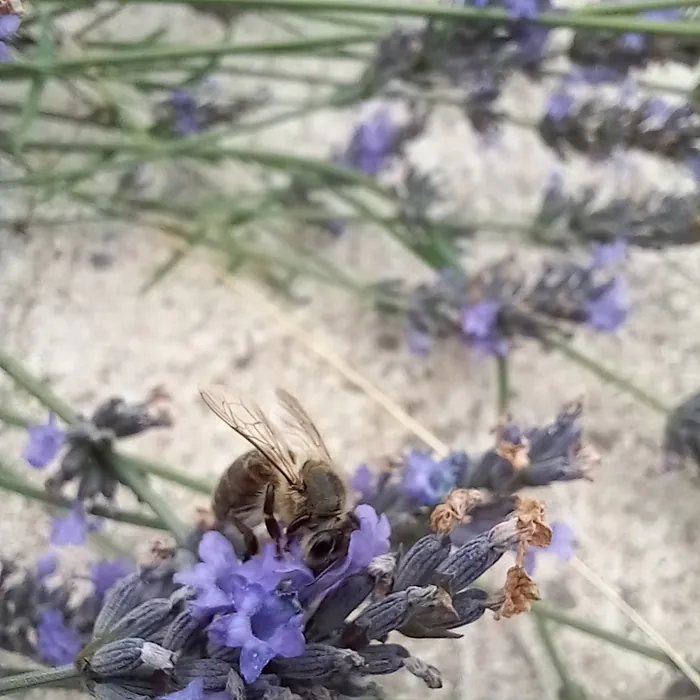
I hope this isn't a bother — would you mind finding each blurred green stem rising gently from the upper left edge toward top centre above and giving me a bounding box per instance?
[0,32,379,79]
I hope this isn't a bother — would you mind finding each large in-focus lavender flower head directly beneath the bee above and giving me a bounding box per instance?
[71,500,551,700]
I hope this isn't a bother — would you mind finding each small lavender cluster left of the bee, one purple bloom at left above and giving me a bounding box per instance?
[24,388,172,504]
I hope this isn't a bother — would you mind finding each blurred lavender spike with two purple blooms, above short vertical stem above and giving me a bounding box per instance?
[388,240,630,355]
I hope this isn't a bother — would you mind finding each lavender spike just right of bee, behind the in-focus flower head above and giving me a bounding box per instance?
[352,402,598,545]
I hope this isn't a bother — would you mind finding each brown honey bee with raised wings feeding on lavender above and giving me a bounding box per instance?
[200,390,359,574]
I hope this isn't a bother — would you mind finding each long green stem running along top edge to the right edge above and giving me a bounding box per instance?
[24,0,700,36]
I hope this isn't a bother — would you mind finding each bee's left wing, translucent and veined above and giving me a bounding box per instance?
[199,390,298,484]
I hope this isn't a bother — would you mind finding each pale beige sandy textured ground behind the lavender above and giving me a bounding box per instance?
[0,2,700,700]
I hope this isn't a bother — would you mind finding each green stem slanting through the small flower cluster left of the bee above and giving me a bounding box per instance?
[0,350,189,544]
